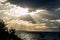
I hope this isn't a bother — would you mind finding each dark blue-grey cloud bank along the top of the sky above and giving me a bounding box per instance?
[8,0,60,8]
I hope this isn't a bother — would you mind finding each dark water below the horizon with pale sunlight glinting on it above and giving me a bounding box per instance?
[16,32,60,40]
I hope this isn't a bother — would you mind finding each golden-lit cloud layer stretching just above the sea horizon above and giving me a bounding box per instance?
[6,20,60,32]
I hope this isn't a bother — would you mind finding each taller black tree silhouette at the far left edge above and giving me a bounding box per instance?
[0,19,9,40]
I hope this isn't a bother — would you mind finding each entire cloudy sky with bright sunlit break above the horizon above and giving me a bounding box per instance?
[0,0,60,31]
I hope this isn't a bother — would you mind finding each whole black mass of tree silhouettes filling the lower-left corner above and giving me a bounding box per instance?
[0,19,21,40]
